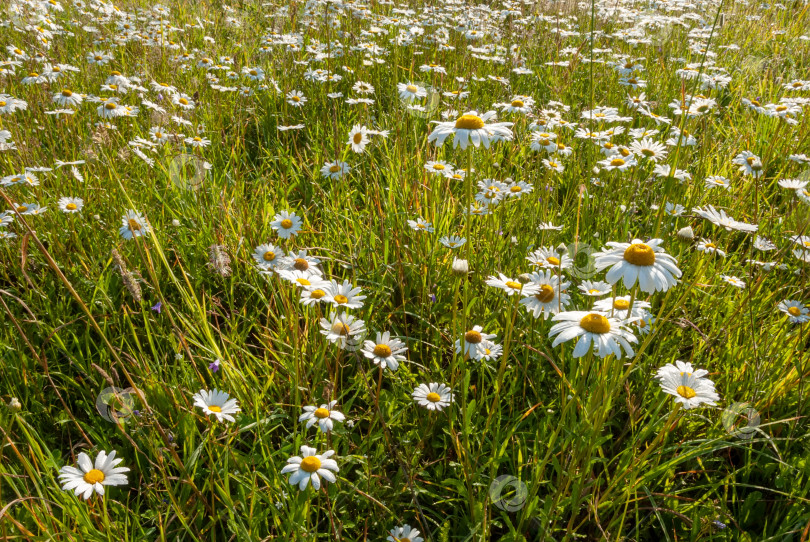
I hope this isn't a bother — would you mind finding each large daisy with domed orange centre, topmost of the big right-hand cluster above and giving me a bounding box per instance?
[594,239,681,293]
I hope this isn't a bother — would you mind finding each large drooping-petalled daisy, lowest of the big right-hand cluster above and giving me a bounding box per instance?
[548,311,638,358]
